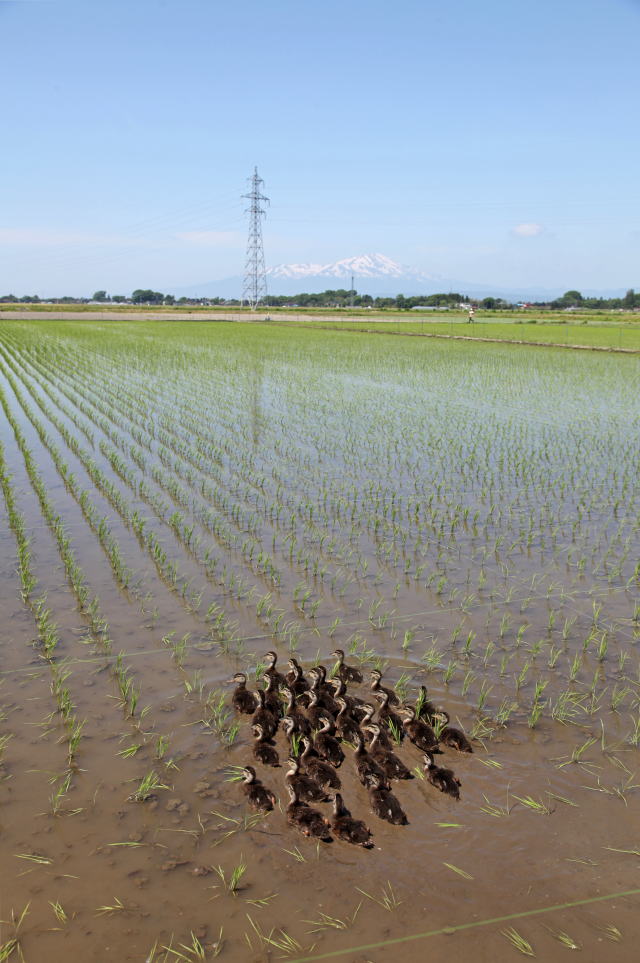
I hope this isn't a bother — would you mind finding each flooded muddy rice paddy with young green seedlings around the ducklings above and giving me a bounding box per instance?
[0,320,640,963]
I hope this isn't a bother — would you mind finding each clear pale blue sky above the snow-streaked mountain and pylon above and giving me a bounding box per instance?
[0,0,640,295]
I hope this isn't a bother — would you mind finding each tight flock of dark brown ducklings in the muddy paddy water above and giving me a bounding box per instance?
[231,649,473,849]
